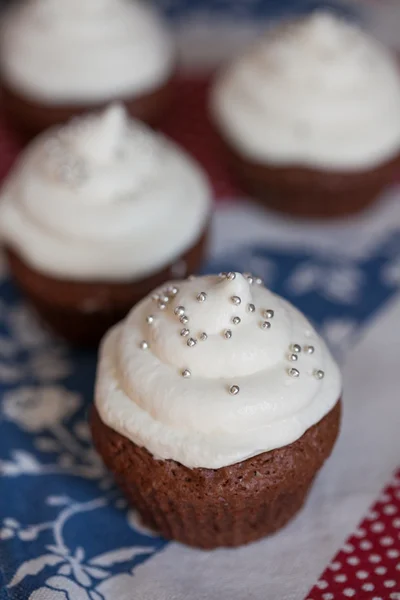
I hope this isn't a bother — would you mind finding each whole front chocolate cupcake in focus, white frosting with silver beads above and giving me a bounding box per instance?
[91,273,341,548]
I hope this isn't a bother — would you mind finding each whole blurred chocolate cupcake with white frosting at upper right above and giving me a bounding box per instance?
[211,12,400,217]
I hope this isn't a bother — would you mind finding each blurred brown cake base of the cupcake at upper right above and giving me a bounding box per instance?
[222,135,400,219]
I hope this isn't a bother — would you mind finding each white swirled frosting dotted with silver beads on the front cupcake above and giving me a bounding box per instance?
[95,273,341,469]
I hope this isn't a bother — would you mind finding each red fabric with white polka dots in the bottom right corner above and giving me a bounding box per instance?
[307,470,400,600]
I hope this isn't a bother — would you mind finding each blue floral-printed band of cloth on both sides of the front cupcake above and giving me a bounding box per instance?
[0,210,400,600]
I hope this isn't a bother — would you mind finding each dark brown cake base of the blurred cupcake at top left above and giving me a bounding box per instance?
[1,77,175,138]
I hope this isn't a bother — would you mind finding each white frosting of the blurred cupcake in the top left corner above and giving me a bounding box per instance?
[0,0,175,104]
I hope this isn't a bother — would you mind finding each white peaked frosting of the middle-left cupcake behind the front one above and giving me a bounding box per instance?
[0,105,211,281]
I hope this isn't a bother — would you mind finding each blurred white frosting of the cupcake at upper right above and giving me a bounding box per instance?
[212,11,400,170]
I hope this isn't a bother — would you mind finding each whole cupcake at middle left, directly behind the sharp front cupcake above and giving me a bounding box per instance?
[0,105,210,344]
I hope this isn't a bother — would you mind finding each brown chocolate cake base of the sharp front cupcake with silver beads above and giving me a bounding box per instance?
[91,401,341,549]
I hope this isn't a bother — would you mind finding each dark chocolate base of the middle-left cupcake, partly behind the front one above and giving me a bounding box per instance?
[6,232,207,346]
